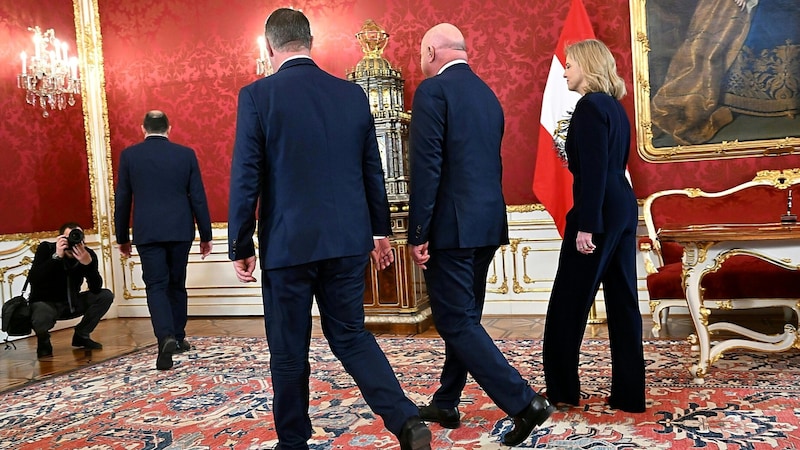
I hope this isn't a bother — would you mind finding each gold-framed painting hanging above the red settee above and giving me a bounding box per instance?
[630,0,800,162]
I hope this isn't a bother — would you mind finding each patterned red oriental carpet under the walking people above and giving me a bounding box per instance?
[0,338,800,450]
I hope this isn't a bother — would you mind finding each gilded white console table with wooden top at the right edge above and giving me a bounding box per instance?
[658,223,800,384]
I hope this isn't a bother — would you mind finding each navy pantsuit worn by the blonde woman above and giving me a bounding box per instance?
[544,93,645,411]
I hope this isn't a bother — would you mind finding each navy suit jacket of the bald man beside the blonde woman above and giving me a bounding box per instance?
[408,64,508,250]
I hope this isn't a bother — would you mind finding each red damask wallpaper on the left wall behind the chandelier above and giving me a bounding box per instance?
[0,1,94,235]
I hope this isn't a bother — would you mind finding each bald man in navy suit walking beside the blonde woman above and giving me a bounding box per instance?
[408,24,555,446]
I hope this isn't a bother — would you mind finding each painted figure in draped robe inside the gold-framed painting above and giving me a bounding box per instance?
[651,0,800,145]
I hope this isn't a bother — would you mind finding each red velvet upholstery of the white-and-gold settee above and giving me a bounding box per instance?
[647,181,800,300]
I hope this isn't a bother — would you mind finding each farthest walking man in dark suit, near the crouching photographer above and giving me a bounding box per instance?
[114,111,212,370]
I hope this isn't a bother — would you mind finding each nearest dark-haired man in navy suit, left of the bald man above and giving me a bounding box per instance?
[228,8,431,450]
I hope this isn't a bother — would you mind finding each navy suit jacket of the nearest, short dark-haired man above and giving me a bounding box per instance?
[228,58,391,269]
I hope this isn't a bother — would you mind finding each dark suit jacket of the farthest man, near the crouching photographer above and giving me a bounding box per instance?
[114,136,211,245]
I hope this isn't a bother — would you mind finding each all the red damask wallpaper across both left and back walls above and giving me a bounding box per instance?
[0,0,800,234]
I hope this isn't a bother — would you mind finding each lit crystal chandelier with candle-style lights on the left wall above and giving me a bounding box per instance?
[17,26,81,117]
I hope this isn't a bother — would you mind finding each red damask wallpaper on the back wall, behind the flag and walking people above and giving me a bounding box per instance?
[100,0,800,217]
